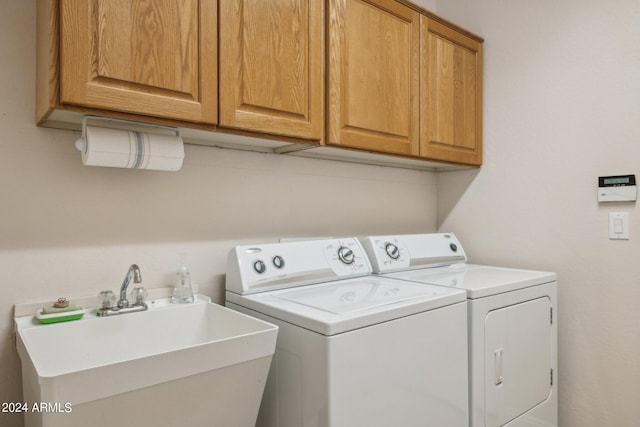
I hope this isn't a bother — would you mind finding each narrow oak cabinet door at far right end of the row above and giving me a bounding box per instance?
[420,16,482,165]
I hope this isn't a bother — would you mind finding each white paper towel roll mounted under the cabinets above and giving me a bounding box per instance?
[76,126,184,171]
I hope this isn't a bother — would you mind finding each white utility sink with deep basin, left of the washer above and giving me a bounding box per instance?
[15,295,277,426]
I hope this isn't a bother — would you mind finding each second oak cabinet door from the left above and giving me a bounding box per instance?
[219,0,324,140]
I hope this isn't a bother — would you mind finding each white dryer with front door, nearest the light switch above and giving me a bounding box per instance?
[361,233,558,427]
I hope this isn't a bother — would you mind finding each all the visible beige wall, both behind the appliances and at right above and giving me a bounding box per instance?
[7,0,640,427]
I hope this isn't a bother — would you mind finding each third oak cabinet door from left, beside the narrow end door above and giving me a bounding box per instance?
[328,0,420,156]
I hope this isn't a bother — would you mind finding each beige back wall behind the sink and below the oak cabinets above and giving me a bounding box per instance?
[0,0,436,427]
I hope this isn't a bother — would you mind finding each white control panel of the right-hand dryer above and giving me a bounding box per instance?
[361,233,467,273]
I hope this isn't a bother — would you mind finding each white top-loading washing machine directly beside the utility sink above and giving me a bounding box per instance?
[226,238,468,427]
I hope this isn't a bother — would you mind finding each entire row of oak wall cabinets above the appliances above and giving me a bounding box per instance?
[36,0,482,165]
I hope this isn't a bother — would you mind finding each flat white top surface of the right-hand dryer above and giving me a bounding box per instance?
[385,264,557,299]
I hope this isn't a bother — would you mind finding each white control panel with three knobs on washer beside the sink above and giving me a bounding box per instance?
[226,237,372,294]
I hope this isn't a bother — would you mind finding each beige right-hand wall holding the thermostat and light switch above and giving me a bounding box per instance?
[437,0,640,427]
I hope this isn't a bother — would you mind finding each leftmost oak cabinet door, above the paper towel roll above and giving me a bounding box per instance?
[60,0,217,123]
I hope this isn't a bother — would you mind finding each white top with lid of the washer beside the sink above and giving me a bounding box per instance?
[227,276,466,336]
